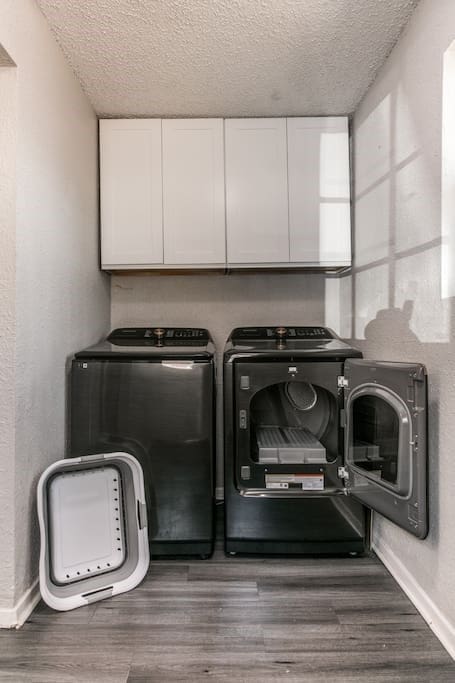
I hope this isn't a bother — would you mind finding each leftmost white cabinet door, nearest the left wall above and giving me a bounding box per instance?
[100,119,163,268]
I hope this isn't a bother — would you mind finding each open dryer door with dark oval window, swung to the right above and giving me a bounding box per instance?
[344,359,428,538]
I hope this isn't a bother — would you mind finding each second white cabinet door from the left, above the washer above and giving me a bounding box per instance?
[163,119,226,265]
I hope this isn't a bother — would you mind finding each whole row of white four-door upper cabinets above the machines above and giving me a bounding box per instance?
[100,116,351,270]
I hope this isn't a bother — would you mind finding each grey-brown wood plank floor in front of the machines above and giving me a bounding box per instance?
[0,510,455,683]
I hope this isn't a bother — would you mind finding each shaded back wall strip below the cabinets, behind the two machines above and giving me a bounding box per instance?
[111,273,324,494]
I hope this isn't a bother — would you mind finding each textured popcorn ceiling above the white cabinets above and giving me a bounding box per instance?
[37,0,418,116]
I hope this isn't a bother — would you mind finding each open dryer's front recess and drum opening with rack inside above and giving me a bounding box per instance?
[235,361,343,496]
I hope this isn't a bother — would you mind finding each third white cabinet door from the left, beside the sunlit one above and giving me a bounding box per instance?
[225,119,289,264]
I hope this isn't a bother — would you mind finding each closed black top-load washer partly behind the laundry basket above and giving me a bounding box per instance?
[69,327,215,558]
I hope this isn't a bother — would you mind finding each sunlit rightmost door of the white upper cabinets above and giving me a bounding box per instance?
[287,117,351,265]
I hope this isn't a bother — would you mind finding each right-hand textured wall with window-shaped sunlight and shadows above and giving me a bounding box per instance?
[350,0,455,655]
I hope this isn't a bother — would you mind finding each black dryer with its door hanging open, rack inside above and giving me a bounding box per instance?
[224,326,428,554]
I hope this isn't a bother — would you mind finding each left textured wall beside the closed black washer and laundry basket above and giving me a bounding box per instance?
[0,0,109,625]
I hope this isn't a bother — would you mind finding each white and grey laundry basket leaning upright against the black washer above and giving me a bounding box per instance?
[38,453,150,610]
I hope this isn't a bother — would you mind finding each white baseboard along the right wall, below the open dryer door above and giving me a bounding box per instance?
[372,541,455,659]
